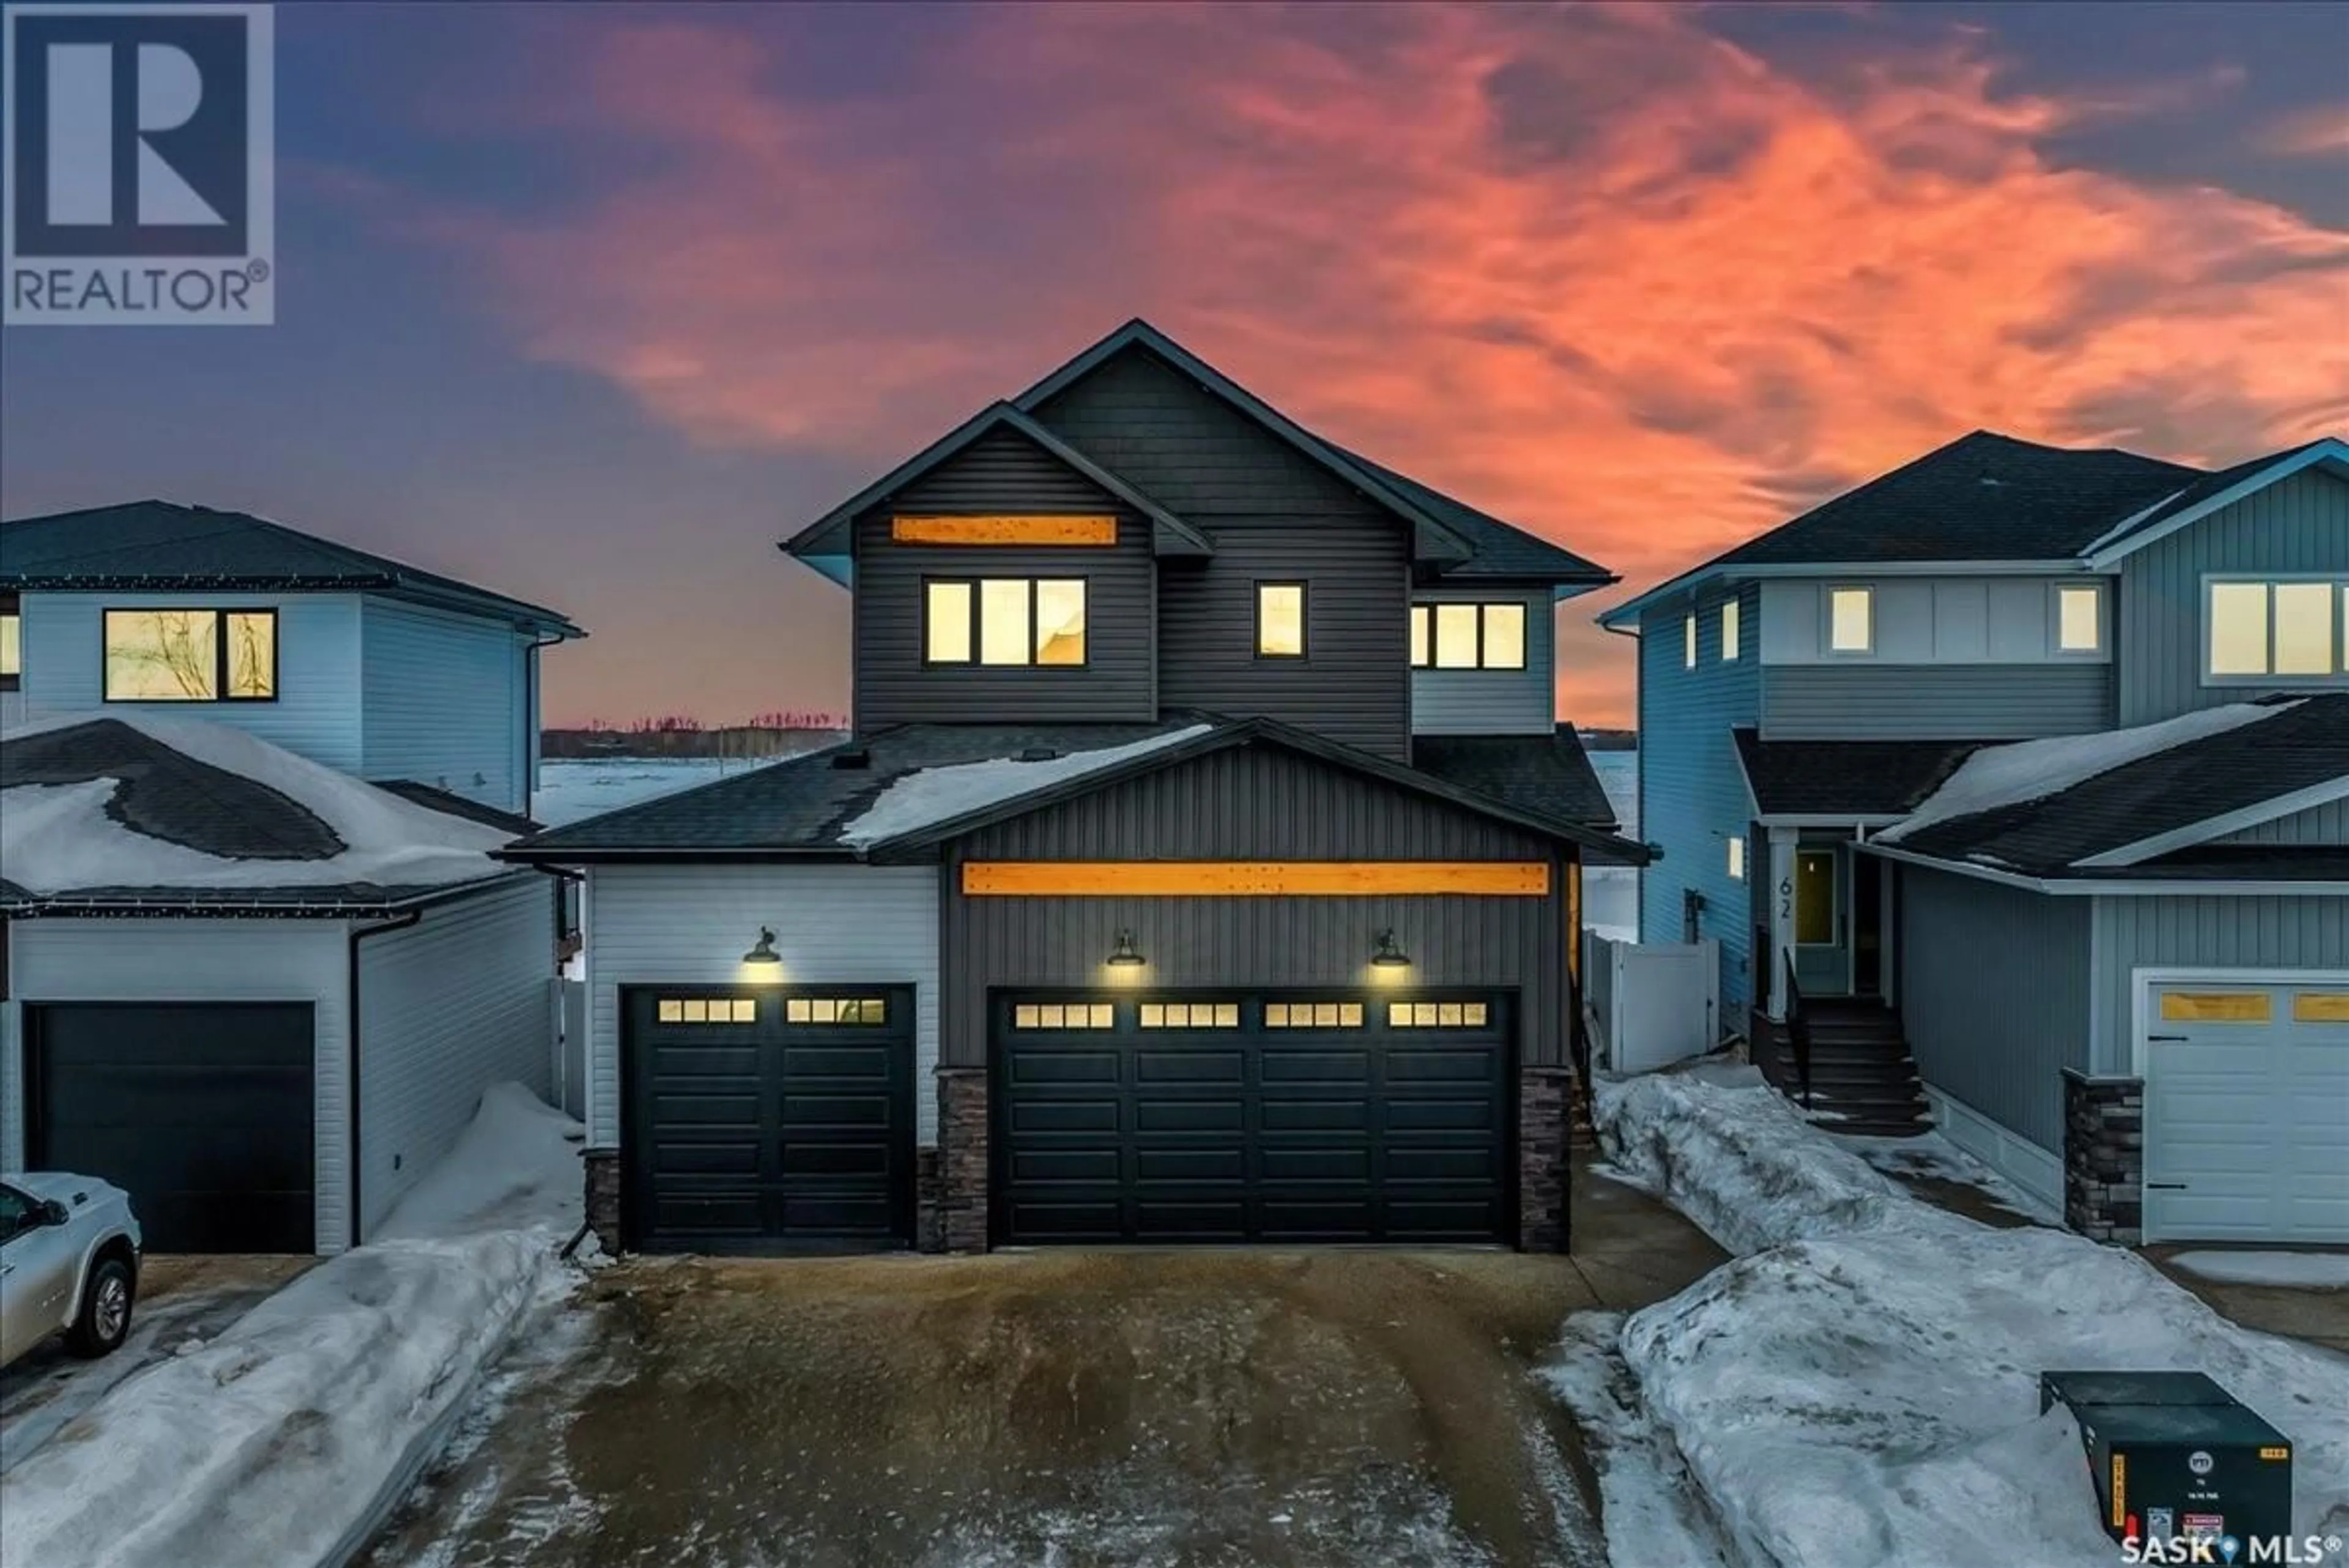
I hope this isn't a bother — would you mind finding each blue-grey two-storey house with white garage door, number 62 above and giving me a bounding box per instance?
[1602,433,2349,1244]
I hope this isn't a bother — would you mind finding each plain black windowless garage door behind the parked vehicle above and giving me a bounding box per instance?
[23,1001,317,1253]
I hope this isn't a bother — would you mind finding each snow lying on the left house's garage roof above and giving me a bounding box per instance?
[0,710,512,896]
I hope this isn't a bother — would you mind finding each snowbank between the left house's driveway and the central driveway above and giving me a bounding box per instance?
[0,1083,580,1568]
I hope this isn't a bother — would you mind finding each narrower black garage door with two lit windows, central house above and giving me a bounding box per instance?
[620,985,914,1253]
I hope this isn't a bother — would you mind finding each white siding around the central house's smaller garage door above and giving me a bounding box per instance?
[587,865,937,1147]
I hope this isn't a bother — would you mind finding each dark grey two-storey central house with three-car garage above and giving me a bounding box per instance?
[507,322,1644,1250]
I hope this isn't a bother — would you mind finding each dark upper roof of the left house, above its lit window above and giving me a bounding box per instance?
[0,500,587,637]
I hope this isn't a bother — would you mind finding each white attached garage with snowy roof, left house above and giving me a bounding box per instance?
[0,719,557,1253]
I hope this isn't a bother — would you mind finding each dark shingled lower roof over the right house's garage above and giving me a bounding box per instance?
[1898,694,2349,877]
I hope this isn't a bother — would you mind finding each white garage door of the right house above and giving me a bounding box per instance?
[2145,976,2349,1241]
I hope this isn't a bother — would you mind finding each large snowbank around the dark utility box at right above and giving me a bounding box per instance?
[1557,1069,2349,1568]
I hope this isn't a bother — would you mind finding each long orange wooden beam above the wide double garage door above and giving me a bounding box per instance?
[963,860,1550,898]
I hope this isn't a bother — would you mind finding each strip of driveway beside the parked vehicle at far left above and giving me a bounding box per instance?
[0,1255,315,1474]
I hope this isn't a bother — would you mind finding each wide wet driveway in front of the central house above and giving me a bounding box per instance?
[360,1161,1720,1568]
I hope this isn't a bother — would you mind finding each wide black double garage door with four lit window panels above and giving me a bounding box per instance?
[993,992,1515,1244]
